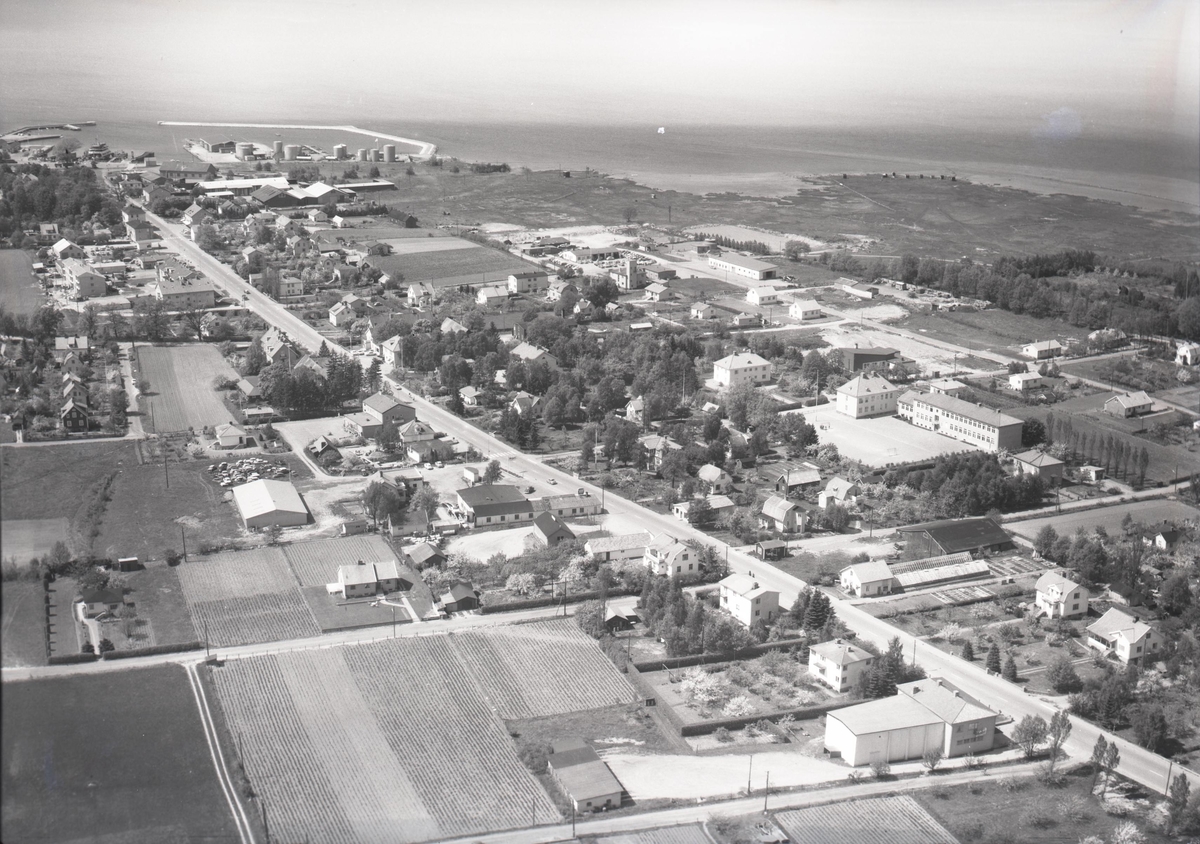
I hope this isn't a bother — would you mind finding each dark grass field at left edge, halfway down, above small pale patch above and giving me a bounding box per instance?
[0,442,138,556]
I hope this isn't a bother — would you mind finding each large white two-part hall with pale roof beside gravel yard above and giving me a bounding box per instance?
[824,677,996,767]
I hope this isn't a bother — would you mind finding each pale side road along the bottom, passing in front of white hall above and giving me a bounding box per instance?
[443,762,1039,844]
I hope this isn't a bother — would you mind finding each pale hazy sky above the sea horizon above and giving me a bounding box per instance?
[0,0,1200,137]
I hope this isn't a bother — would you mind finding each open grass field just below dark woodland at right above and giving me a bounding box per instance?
[900,307,1087,358]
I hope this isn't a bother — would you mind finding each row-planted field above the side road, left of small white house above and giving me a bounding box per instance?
[176,547,320,647]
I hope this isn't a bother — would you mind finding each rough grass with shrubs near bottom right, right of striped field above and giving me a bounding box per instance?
[913,766,1169,844]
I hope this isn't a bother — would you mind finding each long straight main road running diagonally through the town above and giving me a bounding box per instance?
[136,204,1200,791]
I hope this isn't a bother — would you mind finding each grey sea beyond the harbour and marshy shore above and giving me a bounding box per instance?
[0,101,1200,215]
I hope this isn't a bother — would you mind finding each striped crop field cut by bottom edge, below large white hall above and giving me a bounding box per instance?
[775,796,958,844]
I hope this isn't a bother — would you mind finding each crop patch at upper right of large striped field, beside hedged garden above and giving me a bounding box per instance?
[451,618,634,719]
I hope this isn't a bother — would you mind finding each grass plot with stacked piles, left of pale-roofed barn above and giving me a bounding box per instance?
[91,449,248,562]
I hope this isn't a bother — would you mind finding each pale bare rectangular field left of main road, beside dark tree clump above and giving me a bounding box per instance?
[138,345,239,431]
